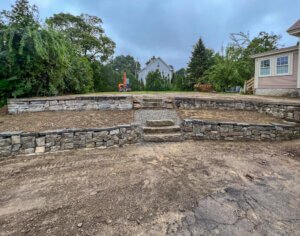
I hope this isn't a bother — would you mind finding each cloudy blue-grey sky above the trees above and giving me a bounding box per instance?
[0,0,300,69]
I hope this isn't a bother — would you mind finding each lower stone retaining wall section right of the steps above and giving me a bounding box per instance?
[181,120,300,141]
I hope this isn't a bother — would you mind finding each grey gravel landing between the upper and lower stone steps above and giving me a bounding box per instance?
[134,109,180,125]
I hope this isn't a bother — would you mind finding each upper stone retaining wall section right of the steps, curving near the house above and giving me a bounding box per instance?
[174,97,300,122]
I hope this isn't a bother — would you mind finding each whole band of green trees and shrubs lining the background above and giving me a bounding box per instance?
[0,0,280,105]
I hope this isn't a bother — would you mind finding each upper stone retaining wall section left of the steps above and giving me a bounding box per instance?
[8,96,133,114]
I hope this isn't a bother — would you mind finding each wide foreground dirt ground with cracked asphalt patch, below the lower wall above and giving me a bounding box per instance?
[0,140,300,235]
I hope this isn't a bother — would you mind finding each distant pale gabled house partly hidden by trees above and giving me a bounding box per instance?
[138,57,174,84]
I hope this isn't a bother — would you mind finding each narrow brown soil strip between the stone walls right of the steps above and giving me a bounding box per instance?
[178,109,283,124]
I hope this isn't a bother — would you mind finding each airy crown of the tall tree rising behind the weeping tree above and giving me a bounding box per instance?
[46,13,115,62]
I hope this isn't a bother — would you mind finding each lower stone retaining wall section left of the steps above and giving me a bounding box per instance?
[0,124,140,157]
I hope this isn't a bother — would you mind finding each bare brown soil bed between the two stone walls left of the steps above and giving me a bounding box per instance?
[0,110,133,131]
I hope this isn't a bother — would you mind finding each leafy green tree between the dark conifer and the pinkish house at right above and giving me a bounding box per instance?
[204,32,280,91]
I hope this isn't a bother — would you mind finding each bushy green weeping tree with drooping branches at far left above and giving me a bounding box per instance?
[0,27,68,97]
